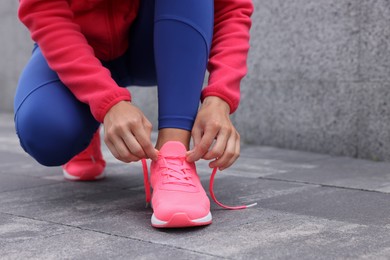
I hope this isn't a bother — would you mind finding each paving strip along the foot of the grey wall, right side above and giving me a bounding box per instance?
[225,146,390,193]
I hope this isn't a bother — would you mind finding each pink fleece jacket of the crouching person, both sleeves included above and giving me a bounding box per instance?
[19,0,253,122]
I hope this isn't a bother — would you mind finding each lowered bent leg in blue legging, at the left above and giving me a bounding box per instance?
[14,46,99,165]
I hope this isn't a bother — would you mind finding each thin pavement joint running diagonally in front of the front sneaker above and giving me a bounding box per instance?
[0,212,227,259]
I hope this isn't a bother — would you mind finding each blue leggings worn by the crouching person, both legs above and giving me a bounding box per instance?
[14,0,213,166]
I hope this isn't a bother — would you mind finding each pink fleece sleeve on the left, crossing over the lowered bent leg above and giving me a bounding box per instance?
[18,0,131,122]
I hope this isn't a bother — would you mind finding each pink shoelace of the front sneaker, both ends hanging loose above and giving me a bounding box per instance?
[142,157,257,210]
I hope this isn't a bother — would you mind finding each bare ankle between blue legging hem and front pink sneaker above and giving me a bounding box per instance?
[156,128,191,150]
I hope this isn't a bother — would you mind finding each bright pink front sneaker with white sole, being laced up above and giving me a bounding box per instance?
[151,141,212,228]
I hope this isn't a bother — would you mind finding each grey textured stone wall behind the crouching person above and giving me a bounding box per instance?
[0,0,390,161]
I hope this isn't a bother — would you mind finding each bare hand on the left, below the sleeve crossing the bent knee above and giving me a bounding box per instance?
[103,101,157,162]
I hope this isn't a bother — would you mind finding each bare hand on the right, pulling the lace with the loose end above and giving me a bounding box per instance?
[187,96,240,170]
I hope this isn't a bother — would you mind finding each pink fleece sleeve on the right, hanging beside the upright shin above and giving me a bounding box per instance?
[201,0,253,113]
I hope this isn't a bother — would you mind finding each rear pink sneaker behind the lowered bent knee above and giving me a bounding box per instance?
[62,131,106,181]
